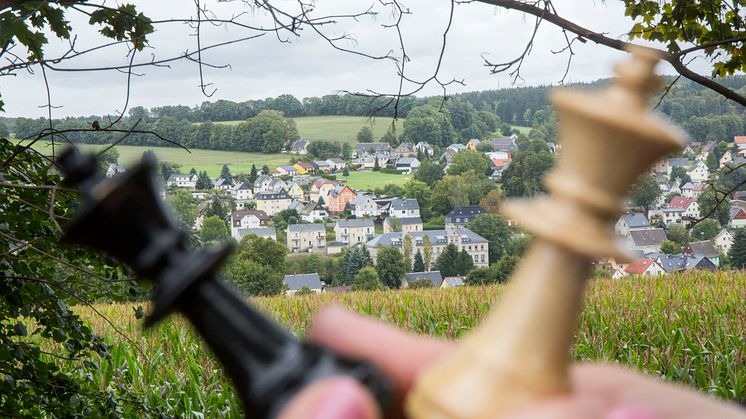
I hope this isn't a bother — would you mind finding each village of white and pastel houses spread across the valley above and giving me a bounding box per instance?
[107,134,746,294]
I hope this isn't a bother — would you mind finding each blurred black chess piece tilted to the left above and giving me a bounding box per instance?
[58,148,393,418]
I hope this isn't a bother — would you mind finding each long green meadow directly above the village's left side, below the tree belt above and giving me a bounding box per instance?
[13,142,290,177]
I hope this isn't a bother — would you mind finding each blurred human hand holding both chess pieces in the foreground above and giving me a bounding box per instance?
[280,307,746,419]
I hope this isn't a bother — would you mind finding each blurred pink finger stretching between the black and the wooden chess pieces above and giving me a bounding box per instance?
[309,306,451,390]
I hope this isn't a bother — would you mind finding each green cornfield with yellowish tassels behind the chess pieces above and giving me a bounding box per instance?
[58,272,746,417]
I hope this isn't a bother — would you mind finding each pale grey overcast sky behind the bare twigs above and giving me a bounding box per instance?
[0,0,696,117]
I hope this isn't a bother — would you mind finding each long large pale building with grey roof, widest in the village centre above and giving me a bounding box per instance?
[365,228,489,268]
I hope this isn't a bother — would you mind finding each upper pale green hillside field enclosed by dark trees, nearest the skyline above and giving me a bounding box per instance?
[215,115,404,144]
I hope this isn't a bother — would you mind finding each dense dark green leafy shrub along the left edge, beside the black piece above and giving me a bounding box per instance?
[0,140,144,417]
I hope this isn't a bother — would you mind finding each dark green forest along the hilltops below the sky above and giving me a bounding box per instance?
[5,76,746,153]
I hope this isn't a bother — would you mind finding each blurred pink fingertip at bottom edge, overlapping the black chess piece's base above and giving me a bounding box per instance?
[279,376,381,419]
